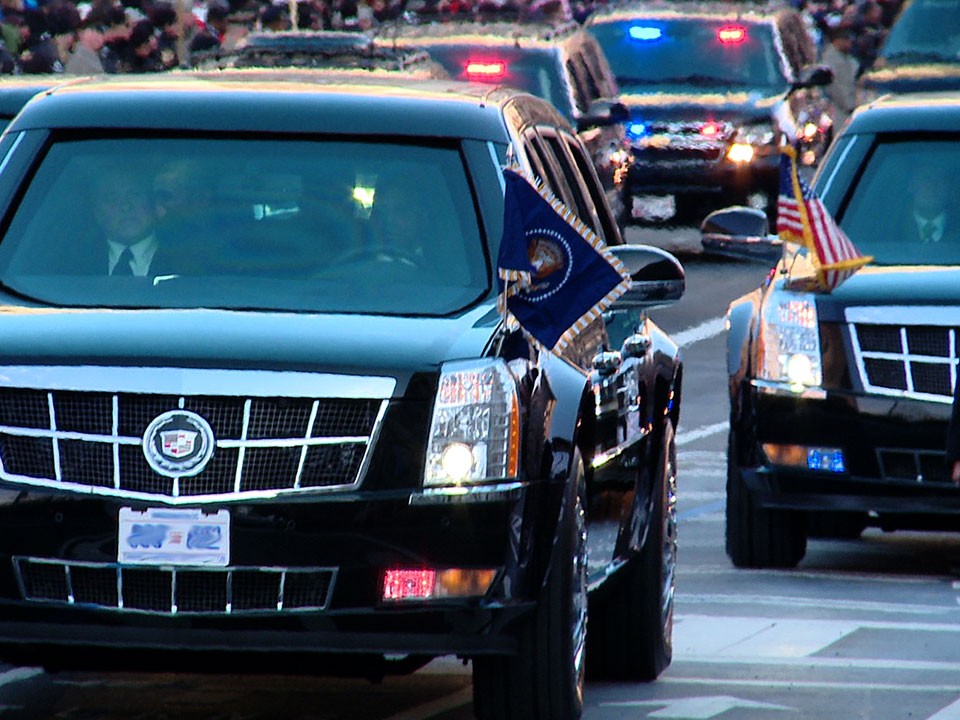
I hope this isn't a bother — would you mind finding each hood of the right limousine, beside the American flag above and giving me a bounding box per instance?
[804,265,960,322]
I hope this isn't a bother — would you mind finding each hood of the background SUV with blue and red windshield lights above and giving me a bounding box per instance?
[620,86,783,123]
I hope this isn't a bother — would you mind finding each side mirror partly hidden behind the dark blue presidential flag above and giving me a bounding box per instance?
[610,245,687,311]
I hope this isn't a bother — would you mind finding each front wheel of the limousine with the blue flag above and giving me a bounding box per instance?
[473,453,587,720]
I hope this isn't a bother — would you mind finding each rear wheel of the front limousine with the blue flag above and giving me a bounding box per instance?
[588,421,677,682]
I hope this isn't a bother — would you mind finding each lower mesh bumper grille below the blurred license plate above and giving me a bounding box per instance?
[13,557,336,615]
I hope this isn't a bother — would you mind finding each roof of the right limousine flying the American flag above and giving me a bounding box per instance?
[844,91,960,134]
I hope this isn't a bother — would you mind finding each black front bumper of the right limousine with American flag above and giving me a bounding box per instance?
[737,384,960,521]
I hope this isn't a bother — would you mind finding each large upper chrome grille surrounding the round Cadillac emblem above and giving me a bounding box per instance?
[0,369,392,504]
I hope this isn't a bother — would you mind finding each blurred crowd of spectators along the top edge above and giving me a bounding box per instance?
[0,0,903,75]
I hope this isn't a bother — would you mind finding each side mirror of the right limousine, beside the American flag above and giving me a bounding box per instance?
[700,205,783,265]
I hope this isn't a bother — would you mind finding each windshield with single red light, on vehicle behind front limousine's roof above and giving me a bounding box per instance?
[418,45,573,120]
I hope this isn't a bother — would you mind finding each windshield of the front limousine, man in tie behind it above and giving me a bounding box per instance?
[0,138,490,315]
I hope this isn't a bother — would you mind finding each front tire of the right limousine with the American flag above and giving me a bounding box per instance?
[727,423,807,568]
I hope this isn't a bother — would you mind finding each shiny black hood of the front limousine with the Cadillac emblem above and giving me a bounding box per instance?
[0,305,499,392]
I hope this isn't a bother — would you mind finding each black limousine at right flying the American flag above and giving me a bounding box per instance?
[704,93,960,567]
